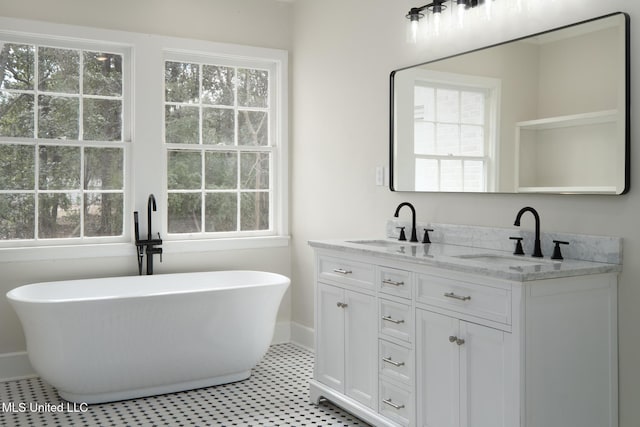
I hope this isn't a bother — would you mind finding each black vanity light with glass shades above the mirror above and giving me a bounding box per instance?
[406,0,494,43]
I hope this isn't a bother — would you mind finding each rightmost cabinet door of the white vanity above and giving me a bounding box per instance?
[460,321,510,427]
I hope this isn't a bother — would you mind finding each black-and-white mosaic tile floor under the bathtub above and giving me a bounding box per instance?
[0,344,367,427]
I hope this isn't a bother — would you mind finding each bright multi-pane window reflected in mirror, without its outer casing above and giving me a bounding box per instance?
[414,75,496,191]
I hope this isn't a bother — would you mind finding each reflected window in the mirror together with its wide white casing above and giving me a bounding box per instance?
[393,69,501,192]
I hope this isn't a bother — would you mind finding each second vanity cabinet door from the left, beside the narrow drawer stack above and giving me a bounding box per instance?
[344,291,378,409]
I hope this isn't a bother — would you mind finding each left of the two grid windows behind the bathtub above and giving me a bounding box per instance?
[0,39,129,245]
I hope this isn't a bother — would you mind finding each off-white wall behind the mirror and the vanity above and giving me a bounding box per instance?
[291,0,640,427]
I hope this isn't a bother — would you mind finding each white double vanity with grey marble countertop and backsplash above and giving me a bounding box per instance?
[309,216,622,427]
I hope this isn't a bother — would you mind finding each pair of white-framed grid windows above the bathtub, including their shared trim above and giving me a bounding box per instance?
[0,17,288,259]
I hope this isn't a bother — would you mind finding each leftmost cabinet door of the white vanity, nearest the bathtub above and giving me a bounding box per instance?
[315,283,346,393]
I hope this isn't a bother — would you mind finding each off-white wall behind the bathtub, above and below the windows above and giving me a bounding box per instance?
[0,0,291,354]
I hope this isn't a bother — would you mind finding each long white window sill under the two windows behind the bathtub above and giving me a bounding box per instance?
[0,236,290,263]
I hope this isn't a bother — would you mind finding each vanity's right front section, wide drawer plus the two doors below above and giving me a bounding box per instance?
[416,270,517,427]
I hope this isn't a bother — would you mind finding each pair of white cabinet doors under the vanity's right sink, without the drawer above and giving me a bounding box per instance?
[416,309,513,427]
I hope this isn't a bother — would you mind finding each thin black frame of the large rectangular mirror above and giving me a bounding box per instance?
[389,12,631,195]
